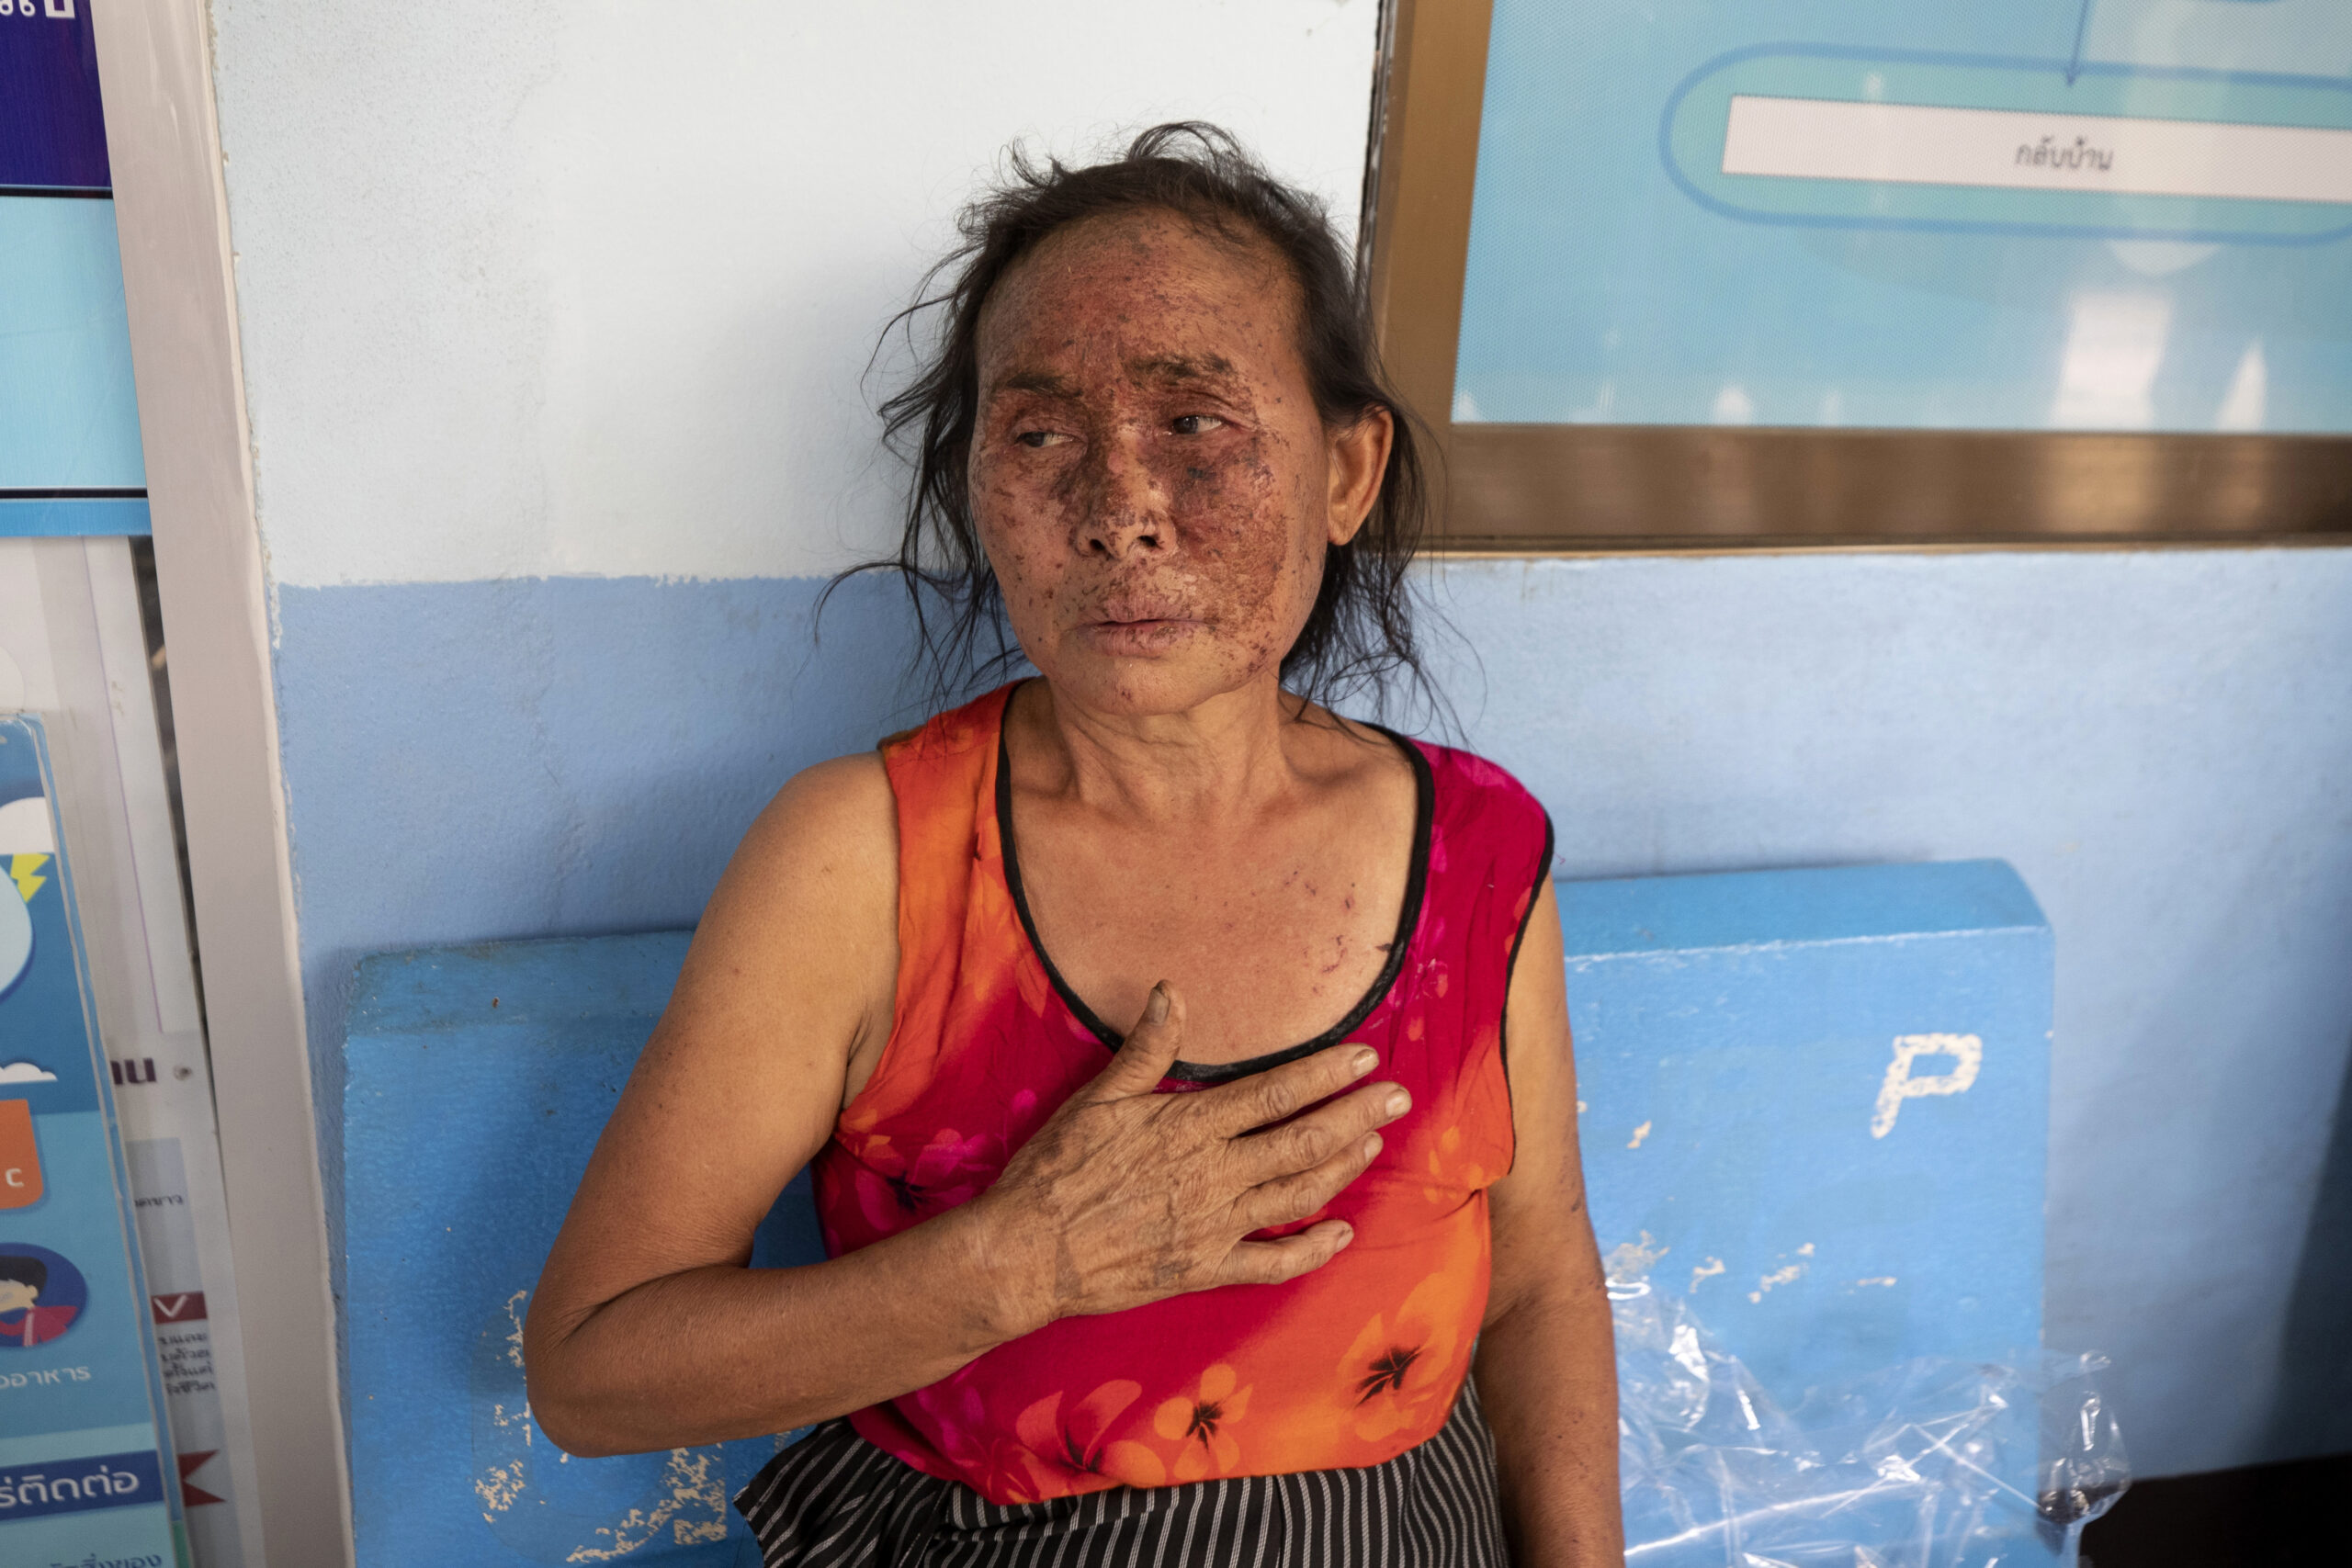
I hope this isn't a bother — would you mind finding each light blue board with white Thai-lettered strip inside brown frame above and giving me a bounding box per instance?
[1453,0,2352,433]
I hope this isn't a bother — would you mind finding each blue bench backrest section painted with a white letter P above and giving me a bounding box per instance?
[1559,861,2051,1404]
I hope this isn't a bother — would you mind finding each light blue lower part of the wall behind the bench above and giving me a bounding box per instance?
[277,550,2352,1474]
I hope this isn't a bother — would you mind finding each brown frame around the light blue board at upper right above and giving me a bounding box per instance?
[1364,0,2352,550]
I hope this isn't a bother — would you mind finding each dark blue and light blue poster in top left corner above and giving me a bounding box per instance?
[0,0,148,538]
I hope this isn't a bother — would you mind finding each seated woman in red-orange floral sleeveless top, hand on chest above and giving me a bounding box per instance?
[526,127,1621,1568]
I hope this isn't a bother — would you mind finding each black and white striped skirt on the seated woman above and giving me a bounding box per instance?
[736,1382,1508,1568]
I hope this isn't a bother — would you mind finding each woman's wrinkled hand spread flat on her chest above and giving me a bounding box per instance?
[981,983,1411,1325]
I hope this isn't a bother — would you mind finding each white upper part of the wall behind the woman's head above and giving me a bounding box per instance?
[214,0,1378,585]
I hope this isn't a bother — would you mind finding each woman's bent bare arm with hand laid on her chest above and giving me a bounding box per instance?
[525,757,1404,1453]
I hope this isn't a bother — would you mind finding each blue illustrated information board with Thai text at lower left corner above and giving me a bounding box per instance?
[0,717,186,1568]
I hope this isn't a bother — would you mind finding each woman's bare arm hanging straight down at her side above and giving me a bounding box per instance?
[1477,882,1625,1568]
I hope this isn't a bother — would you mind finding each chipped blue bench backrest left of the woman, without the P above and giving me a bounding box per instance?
[344,931,823,1568]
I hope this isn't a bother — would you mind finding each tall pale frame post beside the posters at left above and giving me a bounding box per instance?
[92,0,350,1568]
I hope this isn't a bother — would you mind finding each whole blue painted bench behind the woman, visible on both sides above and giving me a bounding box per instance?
[344,861,2051,1568]
